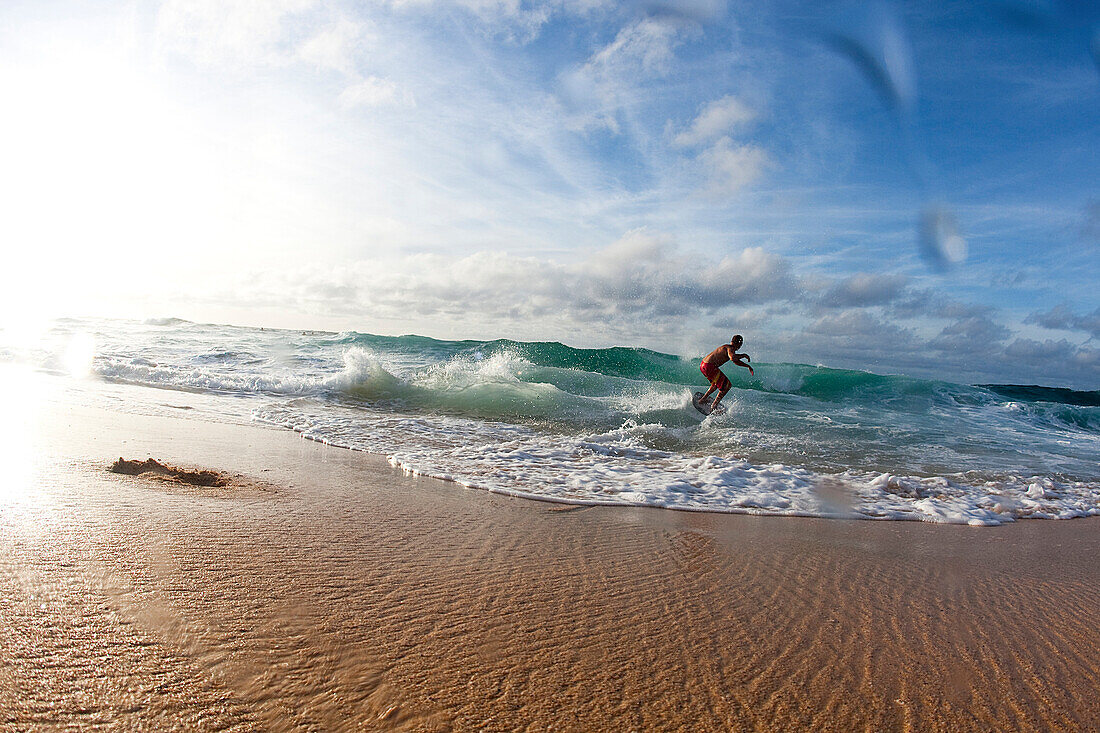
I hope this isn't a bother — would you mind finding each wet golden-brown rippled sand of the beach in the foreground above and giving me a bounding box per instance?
[0,385,1100,731]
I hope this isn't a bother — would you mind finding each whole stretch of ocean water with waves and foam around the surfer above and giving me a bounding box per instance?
[0,319,1100,525]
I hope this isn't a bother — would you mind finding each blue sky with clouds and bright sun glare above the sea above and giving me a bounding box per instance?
[0,0,1100,390]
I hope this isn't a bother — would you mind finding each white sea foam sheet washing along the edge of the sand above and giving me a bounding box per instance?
[256,400,1100,525]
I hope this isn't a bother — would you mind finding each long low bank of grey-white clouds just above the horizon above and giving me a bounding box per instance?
[204,230,1100,387]
